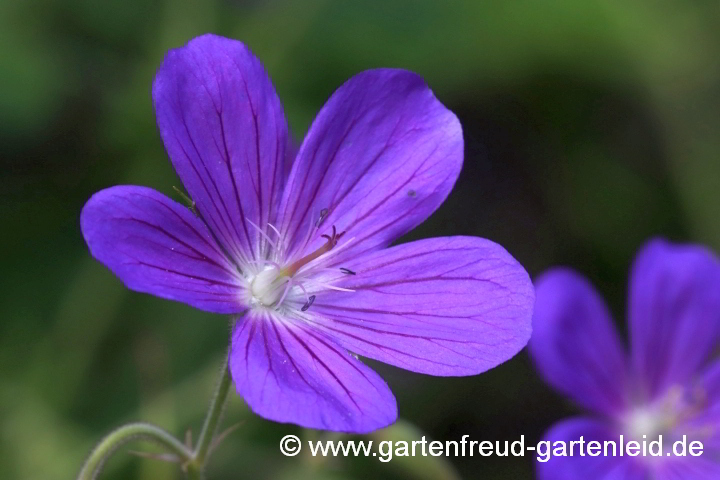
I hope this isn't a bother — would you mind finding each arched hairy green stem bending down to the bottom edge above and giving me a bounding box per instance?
[78,423,193,480]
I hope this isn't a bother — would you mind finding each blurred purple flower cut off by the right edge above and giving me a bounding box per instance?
[529,240,720,480]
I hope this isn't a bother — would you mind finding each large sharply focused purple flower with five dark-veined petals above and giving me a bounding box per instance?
[81,35,534,432]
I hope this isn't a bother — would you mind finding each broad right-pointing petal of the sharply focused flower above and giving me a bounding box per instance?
[310,237,533,376]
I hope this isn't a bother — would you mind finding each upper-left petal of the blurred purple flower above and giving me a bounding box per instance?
[529,268,628,415]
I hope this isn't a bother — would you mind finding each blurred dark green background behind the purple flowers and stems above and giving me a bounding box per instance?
[0,0,720,480]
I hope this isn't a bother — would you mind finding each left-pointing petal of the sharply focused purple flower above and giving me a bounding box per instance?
[80,186,243,313]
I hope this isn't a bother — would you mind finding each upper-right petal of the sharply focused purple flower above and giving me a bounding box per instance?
[282,69,463,262]
